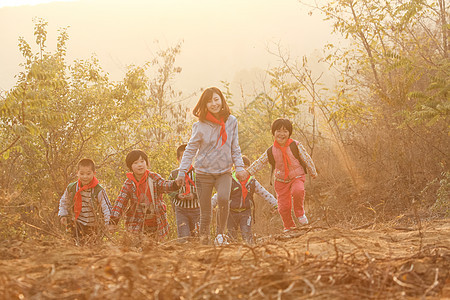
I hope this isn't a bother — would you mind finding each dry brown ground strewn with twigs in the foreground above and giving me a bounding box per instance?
[0,220,450,299]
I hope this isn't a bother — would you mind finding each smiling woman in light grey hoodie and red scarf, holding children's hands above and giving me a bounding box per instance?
[177,87,246,245]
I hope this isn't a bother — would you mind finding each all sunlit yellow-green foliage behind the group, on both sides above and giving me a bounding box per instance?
[0,0,450,239]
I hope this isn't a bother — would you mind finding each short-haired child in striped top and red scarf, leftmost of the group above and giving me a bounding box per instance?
[58,158,111,237]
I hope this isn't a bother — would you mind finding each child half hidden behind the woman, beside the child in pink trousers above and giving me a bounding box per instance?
[212,155,277,244]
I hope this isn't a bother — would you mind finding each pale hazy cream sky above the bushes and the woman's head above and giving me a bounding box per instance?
[0,0,331,102]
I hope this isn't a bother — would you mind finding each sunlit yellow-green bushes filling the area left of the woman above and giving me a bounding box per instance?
[0,19,187,237]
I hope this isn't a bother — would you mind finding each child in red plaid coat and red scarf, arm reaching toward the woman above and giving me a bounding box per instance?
[111,150,178,239]
